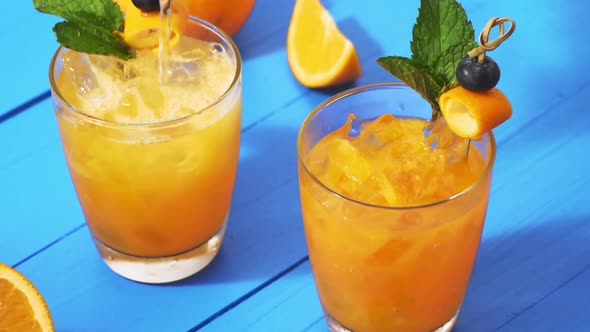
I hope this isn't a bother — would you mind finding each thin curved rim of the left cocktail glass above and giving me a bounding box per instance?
[49,16,242,128]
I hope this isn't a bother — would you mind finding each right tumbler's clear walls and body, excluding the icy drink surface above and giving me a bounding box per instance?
[297,83,496,332]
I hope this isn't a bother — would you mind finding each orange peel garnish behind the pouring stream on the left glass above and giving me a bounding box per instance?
[118,0,189,49]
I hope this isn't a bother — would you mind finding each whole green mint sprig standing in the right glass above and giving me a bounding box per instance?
[377,0,477,118]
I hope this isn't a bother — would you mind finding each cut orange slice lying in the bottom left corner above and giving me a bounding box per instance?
[0,263,54,332]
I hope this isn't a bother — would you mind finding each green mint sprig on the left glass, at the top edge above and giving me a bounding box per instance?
[33,0,135,60]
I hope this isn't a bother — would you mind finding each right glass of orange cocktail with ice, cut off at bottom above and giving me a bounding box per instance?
[297,83,495,332]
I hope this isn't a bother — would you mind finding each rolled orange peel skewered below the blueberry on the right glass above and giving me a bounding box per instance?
[438,87,512,139]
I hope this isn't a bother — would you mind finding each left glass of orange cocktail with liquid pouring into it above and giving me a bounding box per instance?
[50,18,242,283]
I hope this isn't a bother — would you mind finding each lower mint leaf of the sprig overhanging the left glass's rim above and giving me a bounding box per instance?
[53,22,133,60]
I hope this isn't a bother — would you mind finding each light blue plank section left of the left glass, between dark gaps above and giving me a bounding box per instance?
[0,99,84,265]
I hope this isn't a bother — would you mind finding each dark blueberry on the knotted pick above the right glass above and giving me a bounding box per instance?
[456,56,500,91]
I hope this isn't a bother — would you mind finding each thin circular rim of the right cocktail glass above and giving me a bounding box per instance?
[297,82,496,211]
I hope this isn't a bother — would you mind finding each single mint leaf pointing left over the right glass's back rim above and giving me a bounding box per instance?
[377,56,442,112]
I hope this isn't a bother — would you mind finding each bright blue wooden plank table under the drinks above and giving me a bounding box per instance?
[0,0,590,332]
